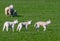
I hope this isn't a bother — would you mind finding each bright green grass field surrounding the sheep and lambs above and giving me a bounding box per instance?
[0,0,60,41]
